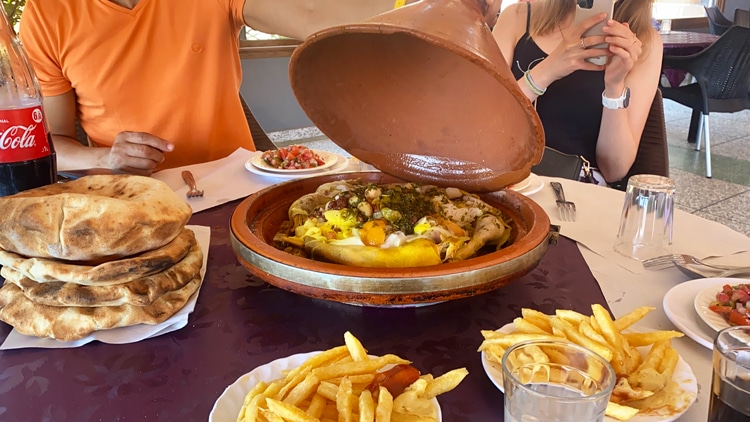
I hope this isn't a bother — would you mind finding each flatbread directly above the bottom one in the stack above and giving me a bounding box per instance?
[0,237,203,307]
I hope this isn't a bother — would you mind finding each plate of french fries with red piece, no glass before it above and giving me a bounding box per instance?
[209,332,468,422]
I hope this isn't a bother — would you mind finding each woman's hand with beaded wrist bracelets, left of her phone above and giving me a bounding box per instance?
[533,13,612,87]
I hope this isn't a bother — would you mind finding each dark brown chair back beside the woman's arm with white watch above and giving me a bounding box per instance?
[610,89,669,191]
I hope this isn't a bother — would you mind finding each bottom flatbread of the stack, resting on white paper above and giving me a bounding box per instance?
[0,275,201,341]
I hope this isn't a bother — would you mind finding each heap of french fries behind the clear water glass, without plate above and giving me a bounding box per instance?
[479,304,683,420]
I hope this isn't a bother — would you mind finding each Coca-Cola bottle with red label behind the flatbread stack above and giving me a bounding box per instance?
[0,7,57,196]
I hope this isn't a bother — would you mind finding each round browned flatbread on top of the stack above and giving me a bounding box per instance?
[0,175,192,262]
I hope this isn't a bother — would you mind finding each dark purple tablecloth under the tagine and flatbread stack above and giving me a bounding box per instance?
[0,202,605,422]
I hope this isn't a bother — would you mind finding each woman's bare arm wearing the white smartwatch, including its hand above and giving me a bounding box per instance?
[596,27,663,182]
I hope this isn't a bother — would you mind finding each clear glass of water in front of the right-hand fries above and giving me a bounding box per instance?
[501,340,615,422]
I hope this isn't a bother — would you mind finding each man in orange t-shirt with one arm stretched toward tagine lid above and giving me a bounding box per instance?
[20,0,506,174]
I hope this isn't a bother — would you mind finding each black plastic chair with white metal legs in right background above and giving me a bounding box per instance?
[661,26,750,178]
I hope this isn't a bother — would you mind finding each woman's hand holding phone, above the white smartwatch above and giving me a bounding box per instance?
[603,20,643,94]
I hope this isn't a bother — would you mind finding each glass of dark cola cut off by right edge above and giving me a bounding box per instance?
[708,326,750,422]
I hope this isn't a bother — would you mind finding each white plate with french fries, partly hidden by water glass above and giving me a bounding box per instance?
[479,304,698,422]
